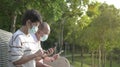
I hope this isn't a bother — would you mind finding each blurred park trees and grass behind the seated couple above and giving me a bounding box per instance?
[0,0,120,67]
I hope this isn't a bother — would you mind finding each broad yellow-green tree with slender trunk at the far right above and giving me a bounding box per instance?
[81,3,120,67]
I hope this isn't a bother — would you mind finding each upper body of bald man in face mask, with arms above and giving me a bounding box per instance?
[31,22,59,67]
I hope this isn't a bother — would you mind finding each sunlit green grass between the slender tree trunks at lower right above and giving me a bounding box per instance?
[68,57,120,67]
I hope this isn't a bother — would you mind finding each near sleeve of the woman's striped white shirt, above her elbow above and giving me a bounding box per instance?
[9,36,24,62]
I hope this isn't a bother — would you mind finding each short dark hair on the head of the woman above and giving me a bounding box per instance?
[22,9,42,25]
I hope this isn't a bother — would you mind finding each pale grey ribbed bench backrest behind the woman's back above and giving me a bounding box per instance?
[0,29,12,67]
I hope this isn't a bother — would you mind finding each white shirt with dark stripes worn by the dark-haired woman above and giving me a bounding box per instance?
[8,30,37,67]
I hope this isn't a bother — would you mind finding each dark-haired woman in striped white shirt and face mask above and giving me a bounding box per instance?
[8,10,42,67]
